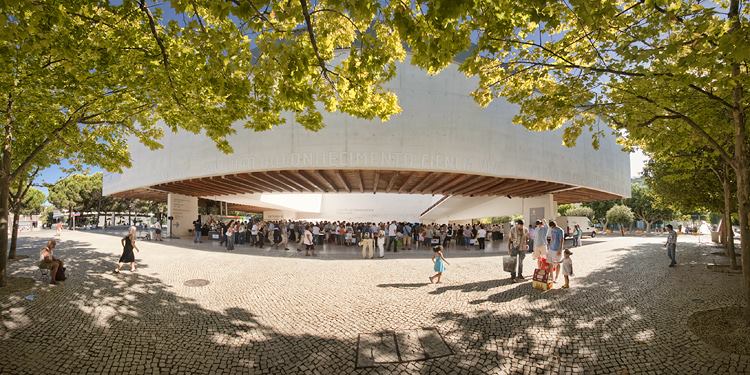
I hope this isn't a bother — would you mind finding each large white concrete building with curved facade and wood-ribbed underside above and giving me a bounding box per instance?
[104,53,630,233]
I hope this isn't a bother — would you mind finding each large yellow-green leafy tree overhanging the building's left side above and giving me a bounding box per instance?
[0,0,424,286]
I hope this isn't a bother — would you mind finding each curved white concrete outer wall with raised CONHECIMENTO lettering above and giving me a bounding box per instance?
[104,53,630,201]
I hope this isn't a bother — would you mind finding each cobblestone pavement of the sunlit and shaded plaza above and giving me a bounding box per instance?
[0,231,750,374]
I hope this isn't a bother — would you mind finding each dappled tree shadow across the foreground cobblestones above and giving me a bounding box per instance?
[0,238,750,374]
